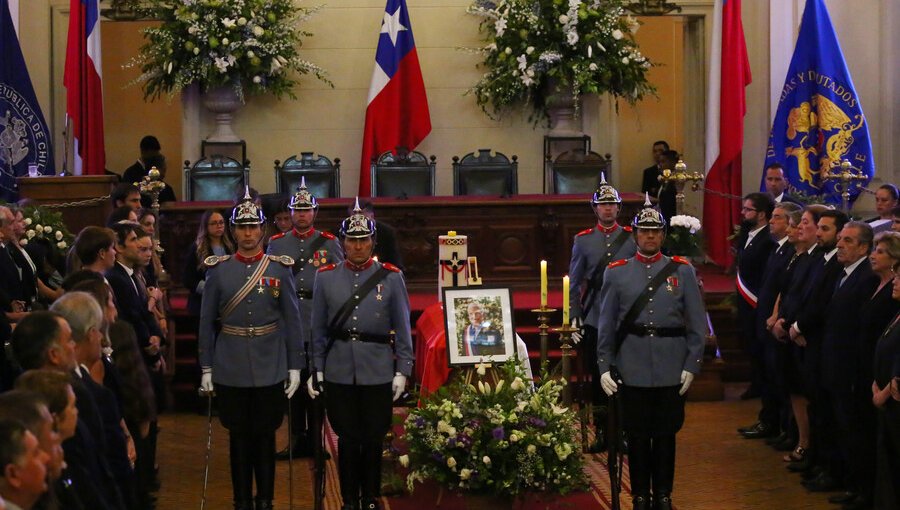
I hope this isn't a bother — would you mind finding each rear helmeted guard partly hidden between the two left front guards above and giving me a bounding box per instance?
[268,178,344,460]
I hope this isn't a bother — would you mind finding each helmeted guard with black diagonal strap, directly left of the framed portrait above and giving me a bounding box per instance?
[307,201,413,510]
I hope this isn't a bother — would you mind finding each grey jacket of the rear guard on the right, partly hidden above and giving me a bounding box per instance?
[569,224,637,328]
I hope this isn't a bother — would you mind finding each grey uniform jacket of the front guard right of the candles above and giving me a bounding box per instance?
[597,254,707,387]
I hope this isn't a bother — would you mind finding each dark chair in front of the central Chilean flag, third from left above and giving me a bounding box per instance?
[371,147,436,198]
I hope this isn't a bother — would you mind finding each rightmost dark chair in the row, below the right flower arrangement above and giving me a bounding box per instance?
[544,149,612,195]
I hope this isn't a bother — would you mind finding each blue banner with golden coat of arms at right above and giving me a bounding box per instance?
[760,0,875,203]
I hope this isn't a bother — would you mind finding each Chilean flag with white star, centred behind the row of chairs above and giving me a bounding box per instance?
[359,0,431,197]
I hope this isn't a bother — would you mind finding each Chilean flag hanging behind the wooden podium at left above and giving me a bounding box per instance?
[63,0,106,175]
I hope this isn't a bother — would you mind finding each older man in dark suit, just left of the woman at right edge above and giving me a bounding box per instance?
[820,221,879,510]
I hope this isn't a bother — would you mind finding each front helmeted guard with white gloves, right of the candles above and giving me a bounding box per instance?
[597,195,706,510]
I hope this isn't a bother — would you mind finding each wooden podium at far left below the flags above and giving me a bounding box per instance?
[16,175,119,235]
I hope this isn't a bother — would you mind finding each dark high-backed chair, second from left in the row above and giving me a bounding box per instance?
[275,152,341,198]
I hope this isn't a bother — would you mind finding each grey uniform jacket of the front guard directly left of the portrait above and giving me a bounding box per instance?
[312,259,414,385]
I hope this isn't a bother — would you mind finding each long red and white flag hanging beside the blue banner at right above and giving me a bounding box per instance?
[703,0,751,266]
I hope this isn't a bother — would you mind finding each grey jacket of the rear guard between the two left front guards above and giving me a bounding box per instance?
[267,229,344,346]
